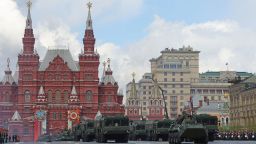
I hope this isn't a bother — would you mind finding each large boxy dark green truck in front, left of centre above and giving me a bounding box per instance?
[95,116,129,143]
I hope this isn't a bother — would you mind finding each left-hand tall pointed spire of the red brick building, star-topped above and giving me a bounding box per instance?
[23,0,35,54]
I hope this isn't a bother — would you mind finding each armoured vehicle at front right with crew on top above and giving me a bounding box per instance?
[169,113,208,144]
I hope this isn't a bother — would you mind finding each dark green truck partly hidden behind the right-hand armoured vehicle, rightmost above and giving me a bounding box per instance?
[195,114,218,141]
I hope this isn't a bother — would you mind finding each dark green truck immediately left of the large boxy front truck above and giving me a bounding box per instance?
[81,120,95,142]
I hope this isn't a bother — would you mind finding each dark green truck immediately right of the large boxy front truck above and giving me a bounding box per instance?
[129,120,147,141]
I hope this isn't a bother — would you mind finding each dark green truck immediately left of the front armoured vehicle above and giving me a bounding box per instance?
[151,119,174,141]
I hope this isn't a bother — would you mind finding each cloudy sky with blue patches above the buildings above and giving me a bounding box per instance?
[0,0,256,94]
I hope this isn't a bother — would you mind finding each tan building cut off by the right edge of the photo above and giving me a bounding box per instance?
[230,76,256,130]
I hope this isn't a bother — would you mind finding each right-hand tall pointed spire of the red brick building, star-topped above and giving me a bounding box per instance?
[83,2,95,54]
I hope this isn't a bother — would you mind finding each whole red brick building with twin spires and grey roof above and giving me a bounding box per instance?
[0,3,124,141]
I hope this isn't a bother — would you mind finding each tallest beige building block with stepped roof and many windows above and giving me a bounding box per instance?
[150,46,200,119]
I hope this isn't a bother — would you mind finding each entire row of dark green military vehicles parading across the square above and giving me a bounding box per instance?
[51,113,218,144]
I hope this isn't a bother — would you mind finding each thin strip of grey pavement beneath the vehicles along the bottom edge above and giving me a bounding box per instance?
[8,141,256,144]
